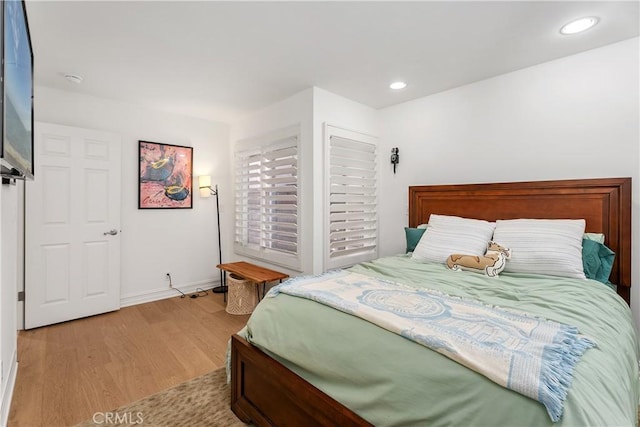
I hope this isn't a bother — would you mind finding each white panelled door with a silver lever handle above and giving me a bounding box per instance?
[25,123,121,329]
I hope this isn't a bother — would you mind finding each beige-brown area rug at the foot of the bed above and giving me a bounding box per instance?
[75,368,246,427]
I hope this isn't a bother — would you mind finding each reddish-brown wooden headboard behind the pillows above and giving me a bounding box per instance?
[409,178,631,303]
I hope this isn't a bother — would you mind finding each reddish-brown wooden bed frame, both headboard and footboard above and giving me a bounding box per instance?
[231,178,631,426]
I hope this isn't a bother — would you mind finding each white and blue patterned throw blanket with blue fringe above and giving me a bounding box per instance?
[267,270,595,422]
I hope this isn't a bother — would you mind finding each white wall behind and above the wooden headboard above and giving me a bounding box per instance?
[380,38,640,322]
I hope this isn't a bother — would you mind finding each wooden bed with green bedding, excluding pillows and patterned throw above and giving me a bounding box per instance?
[230,178,638,426]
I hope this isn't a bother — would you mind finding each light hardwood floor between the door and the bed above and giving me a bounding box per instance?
[8,292,249,427]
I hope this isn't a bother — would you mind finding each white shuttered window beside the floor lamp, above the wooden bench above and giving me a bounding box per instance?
[235,128,301,270]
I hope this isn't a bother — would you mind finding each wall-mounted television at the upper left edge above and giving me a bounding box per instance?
[0,0,34,179]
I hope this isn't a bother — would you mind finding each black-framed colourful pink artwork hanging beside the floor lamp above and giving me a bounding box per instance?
[138,141,193,209]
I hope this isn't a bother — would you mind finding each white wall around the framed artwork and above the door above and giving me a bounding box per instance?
[34,87,232,305]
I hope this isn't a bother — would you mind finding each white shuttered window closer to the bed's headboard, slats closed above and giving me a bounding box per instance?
[325,126,378,269]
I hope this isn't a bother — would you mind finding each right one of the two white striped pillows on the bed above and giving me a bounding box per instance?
[493,219,585,279]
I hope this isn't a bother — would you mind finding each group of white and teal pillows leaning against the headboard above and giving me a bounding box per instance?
[405,214,615,283]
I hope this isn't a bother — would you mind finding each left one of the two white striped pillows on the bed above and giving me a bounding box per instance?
[412,214,495,263]
